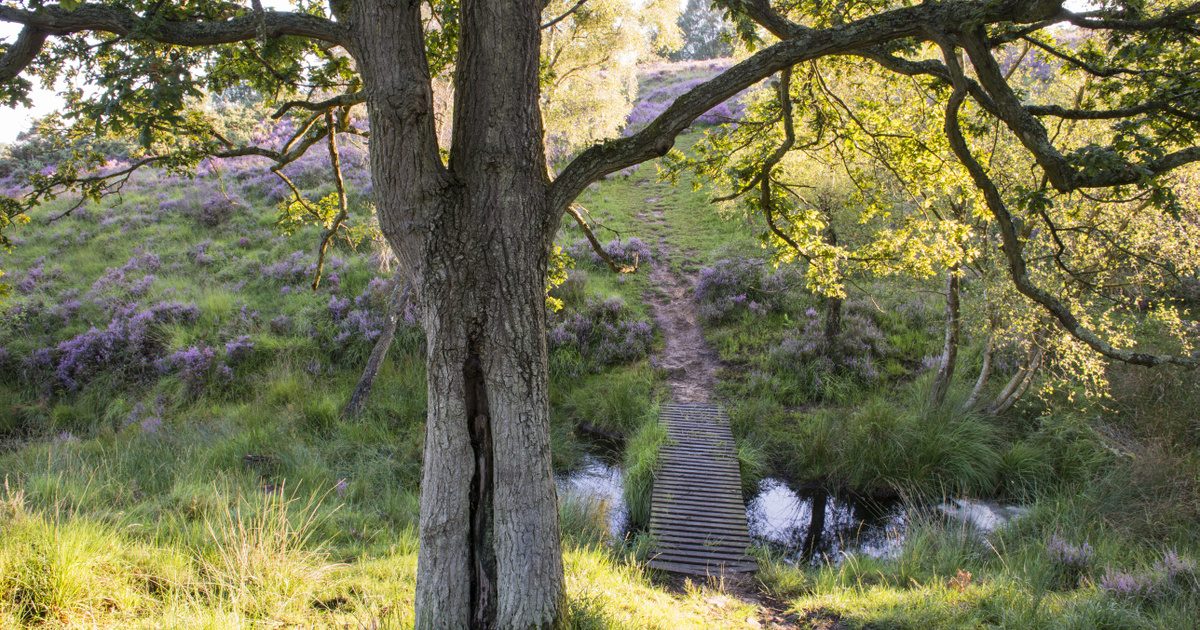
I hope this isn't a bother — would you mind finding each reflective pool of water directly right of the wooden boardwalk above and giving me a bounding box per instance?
[746,478,907,563]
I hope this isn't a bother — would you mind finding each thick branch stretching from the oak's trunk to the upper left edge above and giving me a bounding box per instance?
[0,2,348,46]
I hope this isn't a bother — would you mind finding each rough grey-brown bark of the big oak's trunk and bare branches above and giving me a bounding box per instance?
[0,0,1200,629]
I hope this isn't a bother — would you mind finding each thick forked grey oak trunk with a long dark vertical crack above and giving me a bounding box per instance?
[350,0,563,630]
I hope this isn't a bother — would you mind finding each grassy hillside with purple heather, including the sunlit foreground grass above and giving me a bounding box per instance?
[0,60,1200,628]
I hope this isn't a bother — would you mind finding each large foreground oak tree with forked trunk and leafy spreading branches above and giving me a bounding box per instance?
[0,0,1200,629]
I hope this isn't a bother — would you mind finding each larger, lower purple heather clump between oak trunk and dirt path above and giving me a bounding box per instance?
[547,298,654,367]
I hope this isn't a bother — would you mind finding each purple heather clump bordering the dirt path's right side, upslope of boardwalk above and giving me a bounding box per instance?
[695,258,787,322]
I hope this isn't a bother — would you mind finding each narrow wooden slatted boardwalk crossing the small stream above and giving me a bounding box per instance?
[649,403,758,575]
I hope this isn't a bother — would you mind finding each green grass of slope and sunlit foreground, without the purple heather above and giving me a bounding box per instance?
[0,76,1200,629]
